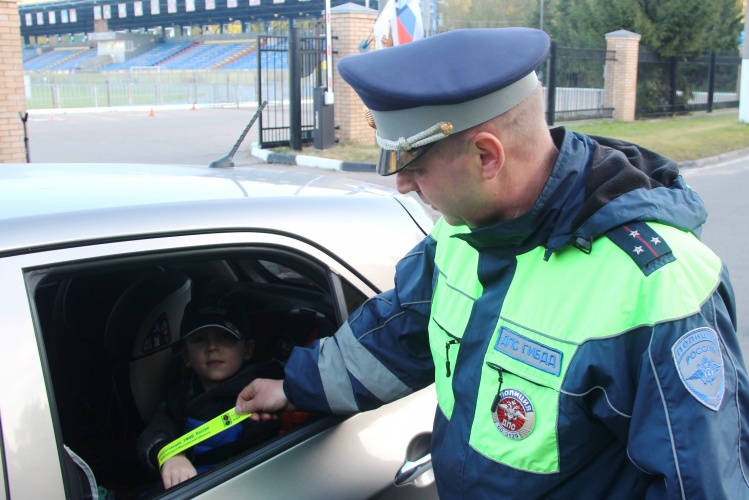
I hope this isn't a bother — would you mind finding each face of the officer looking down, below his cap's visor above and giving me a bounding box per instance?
[395,135,487,227]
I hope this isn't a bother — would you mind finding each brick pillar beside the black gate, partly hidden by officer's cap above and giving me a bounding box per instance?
[330,3,377,144]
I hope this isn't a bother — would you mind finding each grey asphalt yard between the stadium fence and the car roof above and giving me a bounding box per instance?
[28,108,272,165]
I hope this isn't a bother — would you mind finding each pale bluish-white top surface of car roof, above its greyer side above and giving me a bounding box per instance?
[0,163,393,219]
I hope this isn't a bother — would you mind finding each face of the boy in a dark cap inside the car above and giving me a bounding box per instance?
[185,327,255,389]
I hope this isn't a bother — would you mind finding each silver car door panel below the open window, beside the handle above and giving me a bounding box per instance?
[197,391,437,500]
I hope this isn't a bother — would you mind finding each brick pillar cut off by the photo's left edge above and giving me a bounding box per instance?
[0,0,26,163]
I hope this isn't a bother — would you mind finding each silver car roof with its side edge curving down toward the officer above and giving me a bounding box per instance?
[0,163,431,290]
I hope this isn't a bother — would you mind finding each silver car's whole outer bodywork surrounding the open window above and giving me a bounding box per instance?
[0,165,435,498]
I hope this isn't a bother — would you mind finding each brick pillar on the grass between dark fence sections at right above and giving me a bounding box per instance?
[604,30,640,122]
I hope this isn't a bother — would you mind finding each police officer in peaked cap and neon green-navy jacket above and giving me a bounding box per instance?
[237,28,749,499]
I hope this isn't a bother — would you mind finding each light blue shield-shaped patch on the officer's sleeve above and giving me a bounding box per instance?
[671,327,726,411]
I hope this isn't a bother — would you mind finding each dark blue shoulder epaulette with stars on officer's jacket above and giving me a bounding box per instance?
[606,222,676,276]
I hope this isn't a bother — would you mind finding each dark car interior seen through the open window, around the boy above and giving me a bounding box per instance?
[30,248,366,498]
